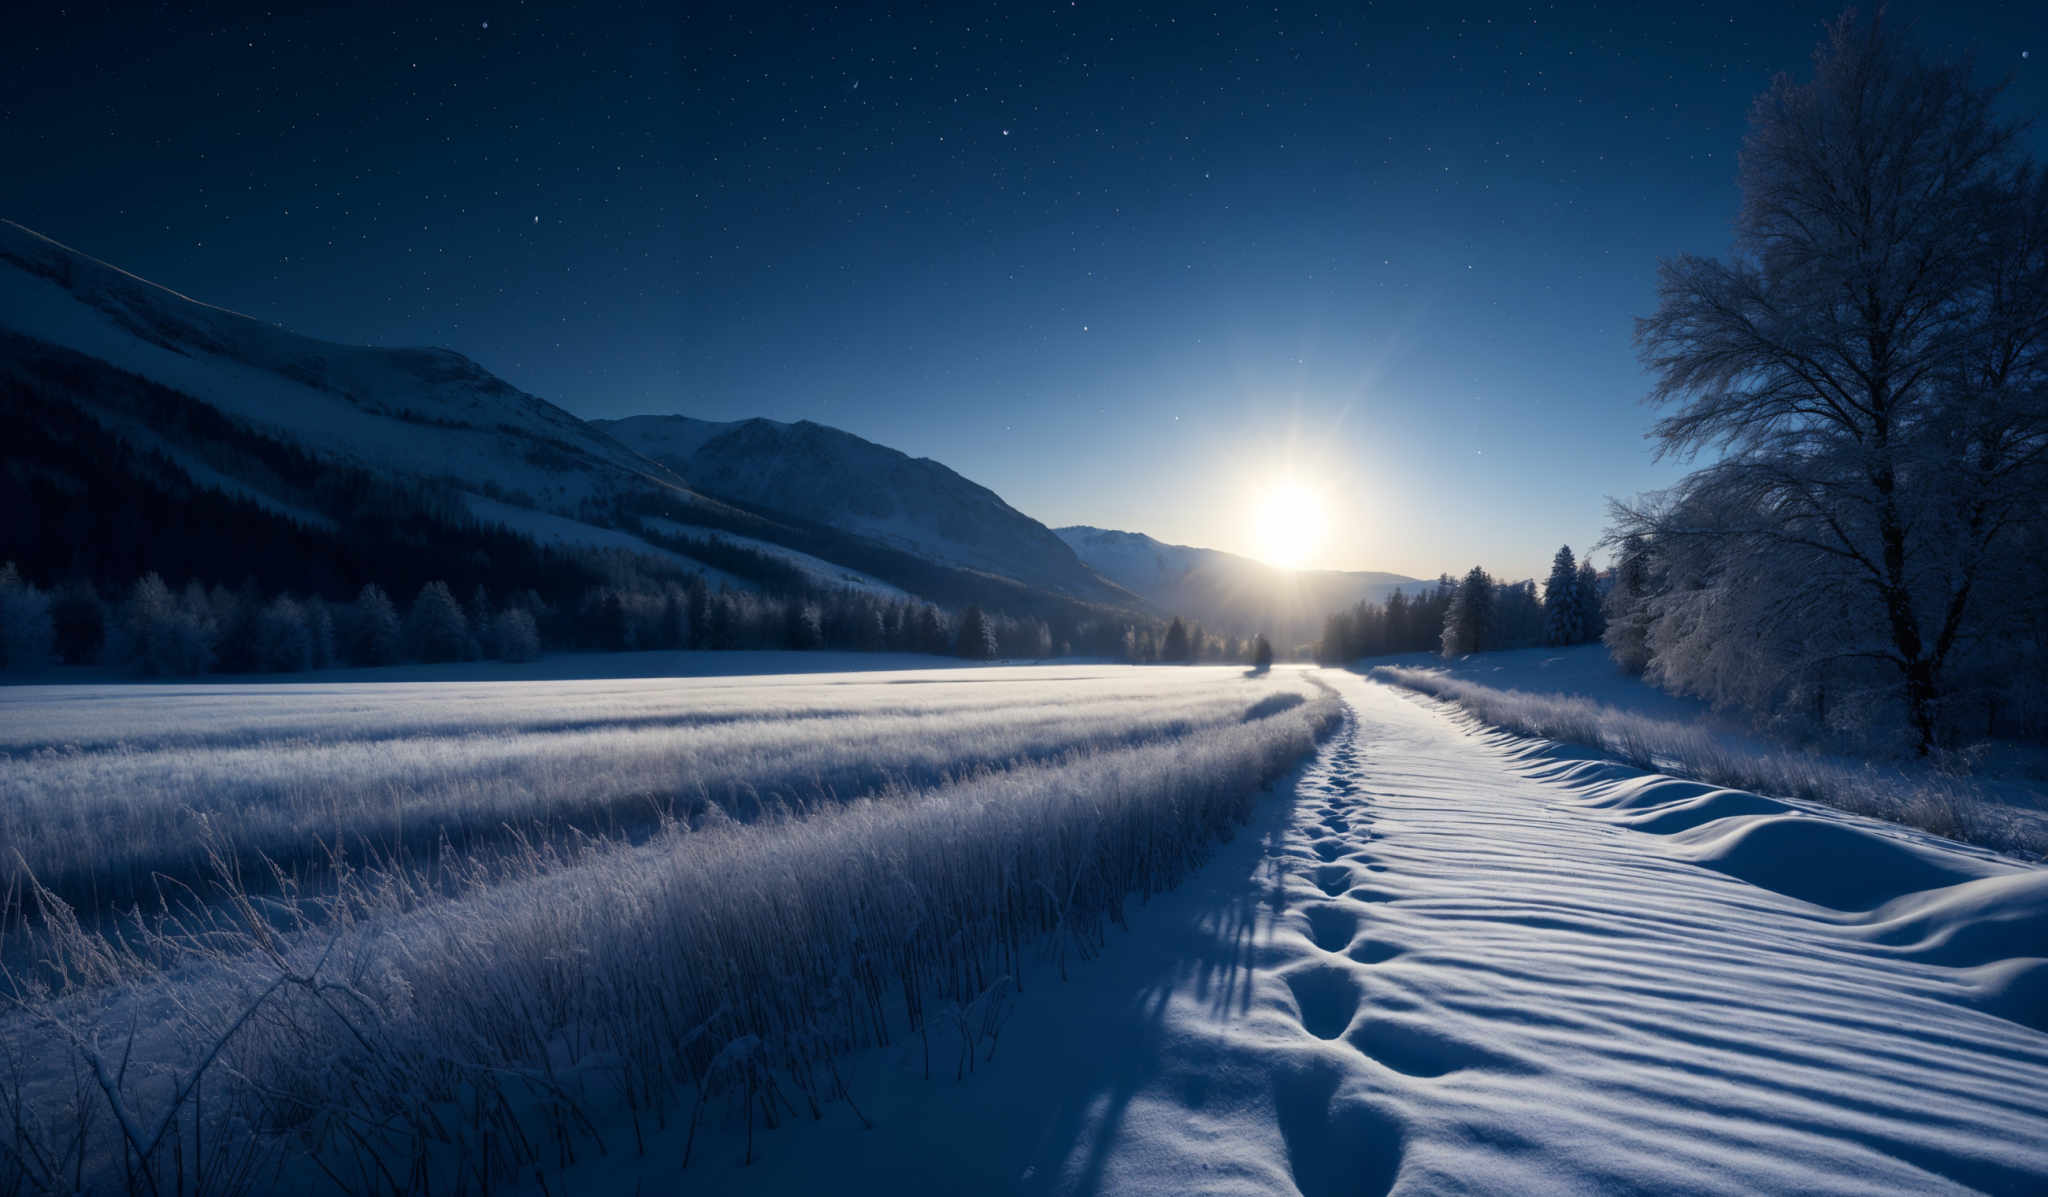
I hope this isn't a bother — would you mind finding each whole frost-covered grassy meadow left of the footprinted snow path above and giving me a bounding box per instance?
[0,666,1341,1191]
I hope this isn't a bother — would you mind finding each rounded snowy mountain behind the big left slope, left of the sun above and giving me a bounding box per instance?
[592,416,1130,605]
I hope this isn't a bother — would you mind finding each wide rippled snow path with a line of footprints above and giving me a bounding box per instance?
[675,674,2048,1195]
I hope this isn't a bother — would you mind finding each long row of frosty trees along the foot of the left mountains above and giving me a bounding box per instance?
[0,564,1196,676]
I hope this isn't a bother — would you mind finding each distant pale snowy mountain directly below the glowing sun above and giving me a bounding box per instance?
[1053,525,1434,646]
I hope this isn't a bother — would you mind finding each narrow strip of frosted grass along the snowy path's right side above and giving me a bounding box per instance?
[1368,666,2048,859]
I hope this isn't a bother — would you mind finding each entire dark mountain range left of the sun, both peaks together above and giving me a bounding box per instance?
[0,221,1143,617]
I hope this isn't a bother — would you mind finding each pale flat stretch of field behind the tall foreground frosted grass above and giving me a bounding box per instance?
[0,666,1298,908]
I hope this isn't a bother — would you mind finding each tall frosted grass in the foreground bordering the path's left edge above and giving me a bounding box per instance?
[0,670,1341,1193]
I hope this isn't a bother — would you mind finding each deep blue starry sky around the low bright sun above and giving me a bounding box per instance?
[0,2,2048,576]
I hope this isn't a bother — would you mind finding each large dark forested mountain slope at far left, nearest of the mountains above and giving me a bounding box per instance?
[0,221,1143,619]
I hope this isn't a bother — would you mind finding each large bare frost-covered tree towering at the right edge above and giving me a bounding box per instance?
[1620,14,2048,752]
